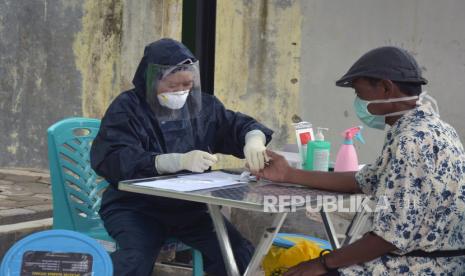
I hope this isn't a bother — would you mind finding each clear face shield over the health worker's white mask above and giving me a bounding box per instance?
[146,59,202,122]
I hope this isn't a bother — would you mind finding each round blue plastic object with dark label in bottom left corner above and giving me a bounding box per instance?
[0,230,113,276]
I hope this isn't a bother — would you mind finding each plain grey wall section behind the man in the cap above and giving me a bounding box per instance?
[300,0,465,162]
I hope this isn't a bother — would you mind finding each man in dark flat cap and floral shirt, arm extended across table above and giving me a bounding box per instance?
[257,47,465,276]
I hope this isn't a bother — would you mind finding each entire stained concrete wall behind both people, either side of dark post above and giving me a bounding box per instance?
[0,0,465,172]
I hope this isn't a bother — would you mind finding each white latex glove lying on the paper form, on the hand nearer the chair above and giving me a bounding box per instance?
[155,150,218,174]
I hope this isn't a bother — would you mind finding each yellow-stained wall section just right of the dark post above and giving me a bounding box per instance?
[215,1,302,167]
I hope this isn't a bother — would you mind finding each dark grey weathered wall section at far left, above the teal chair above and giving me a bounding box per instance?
[0,0,83,167]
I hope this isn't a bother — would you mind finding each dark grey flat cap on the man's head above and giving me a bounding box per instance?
[336,46,428,87]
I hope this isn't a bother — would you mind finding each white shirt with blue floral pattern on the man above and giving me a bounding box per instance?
[339,103,465,275]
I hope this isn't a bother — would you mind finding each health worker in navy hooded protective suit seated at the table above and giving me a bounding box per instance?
[91,39,273,276]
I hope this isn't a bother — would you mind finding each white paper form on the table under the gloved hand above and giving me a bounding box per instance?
[134,172,246,192]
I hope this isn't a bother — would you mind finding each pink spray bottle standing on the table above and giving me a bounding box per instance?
[334,126,365,172]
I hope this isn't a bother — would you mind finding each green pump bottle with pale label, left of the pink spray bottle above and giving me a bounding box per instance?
[304,127,331,172]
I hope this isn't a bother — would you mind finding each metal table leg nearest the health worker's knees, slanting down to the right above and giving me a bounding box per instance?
[208,204,239,276]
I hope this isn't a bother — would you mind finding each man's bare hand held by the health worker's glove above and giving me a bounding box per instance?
[253,150,292,182]
